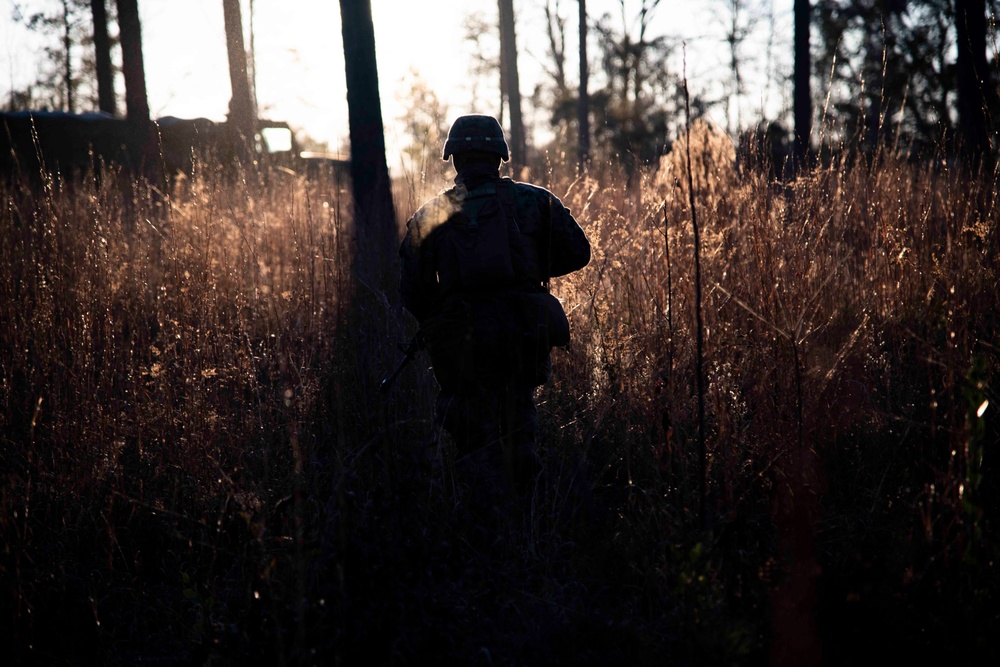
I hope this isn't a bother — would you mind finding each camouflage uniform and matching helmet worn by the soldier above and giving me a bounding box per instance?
[400,116,590,500]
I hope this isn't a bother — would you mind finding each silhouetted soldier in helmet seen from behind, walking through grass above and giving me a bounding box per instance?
[399,115,590,506]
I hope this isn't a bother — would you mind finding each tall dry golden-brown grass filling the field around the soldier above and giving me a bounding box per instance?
[0,136,1000,664]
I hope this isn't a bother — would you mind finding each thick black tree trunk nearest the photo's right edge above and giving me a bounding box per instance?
[955,0,990,169]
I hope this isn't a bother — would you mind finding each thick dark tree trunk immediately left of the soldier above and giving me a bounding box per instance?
[340,0,398,294]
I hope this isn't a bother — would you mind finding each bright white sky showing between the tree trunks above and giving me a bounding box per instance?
[0,0,792,166]
